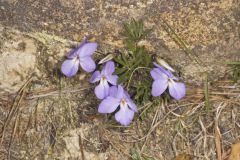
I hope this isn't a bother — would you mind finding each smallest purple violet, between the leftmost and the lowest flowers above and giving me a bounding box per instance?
[90,61,118,99]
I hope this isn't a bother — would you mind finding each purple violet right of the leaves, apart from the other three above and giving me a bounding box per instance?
[151,63,186,100]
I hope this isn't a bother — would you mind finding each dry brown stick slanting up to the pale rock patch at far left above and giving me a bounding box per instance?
[1,77,32,144]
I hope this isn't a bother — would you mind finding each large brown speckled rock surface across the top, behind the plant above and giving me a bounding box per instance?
[0,0,240,83]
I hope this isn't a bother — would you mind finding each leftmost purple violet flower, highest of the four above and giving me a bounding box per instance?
[61,38,97,77]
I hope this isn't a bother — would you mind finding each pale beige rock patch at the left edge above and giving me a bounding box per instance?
[0,26,37,93]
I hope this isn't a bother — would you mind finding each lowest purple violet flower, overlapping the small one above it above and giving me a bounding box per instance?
[98,85,137,126]
